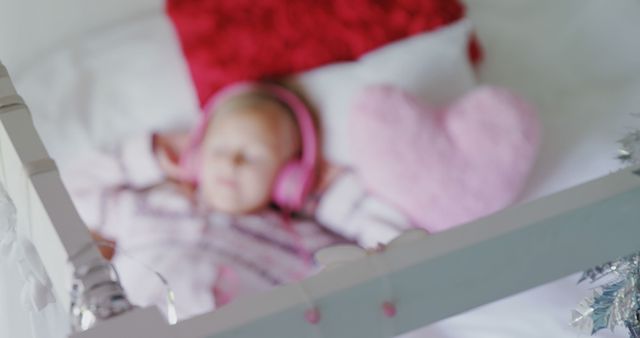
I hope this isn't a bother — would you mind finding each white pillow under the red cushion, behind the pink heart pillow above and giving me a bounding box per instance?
[294,19,476,165]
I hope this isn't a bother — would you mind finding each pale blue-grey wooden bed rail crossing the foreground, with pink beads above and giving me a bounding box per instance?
[77,162,640,338]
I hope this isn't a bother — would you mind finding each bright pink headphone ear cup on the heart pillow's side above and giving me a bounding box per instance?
[273,160,314,211]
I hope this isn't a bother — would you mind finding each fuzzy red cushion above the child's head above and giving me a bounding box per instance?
[167,0,479,104]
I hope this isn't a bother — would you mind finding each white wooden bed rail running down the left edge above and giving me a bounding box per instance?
[0,64,100,307]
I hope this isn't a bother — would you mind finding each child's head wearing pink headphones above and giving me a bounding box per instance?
[174,83,317,214]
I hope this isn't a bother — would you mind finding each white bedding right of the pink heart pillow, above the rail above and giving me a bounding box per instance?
[467,0,640,200]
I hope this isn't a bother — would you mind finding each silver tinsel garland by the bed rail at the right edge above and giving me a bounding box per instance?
[572,130,640,338]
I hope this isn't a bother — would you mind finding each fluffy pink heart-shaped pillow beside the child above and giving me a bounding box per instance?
[349,86,539,232]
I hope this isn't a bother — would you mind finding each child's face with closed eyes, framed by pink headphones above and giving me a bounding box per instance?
[200,101,299,214]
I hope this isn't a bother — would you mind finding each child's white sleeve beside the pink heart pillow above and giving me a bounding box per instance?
[315,172,411,248]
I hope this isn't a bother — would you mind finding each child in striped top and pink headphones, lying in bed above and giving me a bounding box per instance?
[63,83,407,318]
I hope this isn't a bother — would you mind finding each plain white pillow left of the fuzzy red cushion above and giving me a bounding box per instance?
[15,12,199,164]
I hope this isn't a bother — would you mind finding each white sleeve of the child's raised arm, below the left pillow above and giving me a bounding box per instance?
[60,134,164,229]
